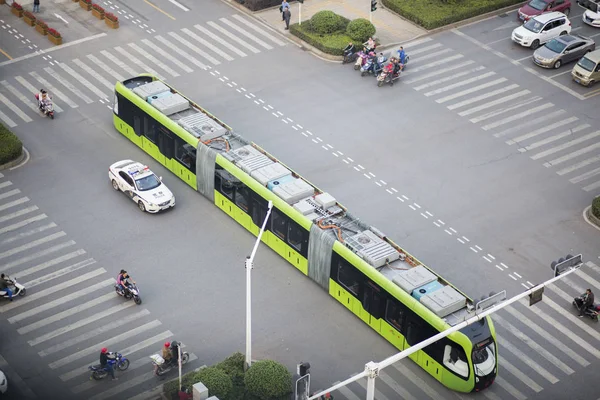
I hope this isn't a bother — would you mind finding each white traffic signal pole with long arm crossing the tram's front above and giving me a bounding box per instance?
[307,256,582,400]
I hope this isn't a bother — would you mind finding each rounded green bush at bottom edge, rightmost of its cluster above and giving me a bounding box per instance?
[244,360,292,400]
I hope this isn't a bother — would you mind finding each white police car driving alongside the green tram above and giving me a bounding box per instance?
[108,160,175,213]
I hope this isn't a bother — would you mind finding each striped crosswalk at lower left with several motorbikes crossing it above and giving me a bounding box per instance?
[0,173,197,400]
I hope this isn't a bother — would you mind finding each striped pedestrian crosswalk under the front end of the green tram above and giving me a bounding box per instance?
[332,261,600,400]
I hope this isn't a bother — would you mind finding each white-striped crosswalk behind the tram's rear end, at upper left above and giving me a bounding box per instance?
[0,14,285,128]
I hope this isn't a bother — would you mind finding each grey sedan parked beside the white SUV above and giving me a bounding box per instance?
[532,35,596,69]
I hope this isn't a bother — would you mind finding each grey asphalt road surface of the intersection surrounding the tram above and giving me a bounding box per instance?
[0,1,600,400]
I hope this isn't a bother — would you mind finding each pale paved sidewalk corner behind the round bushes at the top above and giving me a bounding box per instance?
[253,0,427,46]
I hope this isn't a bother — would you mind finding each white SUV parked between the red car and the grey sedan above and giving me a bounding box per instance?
[511,11,571,50]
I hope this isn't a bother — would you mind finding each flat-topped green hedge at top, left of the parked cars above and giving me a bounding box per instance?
[383,0,523,29]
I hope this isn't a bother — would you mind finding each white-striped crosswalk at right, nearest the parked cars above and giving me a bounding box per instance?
[400,38,600,194]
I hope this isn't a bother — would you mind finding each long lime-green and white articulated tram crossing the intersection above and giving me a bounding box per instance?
[114,74,498,392]
